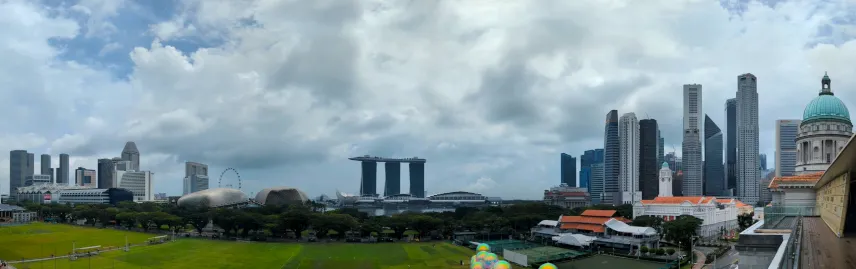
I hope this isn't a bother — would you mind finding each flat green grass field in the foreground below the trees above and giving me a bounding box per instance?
[0,223,473,269]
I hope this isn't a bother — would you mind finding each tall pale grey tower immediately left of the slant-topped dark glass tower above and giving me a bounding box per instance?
[681,84,703,196]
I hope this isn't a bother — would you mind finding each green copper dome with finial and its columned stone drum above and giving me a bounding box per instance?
[795,74,853,175]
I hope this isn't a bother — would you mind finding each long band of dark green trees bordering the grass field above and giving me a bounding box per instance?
[23,201,632,239]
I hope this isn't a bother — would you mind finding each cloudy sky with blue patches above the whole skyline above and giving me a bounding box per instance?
[0,0,856,198]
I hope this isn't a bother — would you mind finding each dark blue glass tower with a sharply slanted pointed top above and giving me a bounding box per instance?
[704,114,725,196]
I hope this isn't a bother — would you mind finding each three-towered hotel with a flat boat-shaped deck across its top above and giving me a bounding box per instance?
[348,155,426,198]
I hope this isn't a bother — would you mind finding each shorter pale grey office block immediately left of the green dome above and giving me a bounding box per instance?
[774,120,802,177]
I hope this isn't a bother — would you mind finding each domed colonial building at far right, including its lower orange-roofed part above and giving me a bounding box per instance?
[767,74,853,207]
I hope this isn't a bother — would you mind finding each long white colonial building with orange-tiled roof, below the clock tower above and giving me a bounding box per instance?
[633,196,750,237]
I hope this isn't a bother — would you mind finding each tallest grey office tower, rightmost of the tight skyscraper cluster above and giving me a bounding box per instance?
[737,73,761,205]
